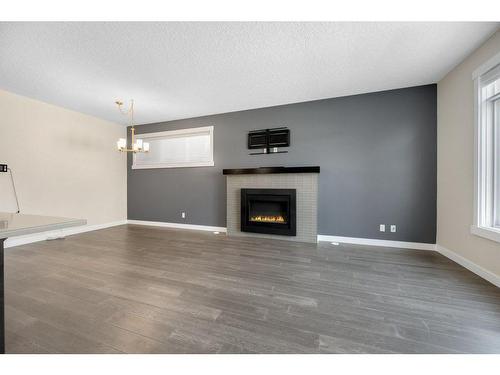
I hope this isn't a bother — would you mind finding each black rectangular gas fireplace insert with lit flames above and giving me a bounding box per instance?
[241,189,297,236]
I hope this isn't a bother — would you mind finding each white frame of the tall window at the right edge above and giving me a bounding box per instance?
[471,53,500,242]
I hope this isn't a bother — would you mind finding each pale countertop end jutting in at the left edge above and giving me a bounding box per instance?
[0,212,87,239]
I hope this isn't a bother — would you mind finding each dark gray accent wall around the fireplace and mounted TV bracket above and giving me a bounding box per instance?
[127,85,437,243]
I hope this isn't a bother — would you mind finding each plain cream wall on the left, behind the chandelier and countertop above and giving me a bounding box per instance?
[0,90,127,228]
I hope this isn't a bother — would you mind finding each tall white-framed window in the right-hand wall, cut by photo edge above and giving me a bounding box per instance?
[472,55,500,242]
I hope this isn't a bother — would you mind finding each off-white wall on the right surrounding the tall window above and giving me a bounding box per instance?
[437,31,500,280]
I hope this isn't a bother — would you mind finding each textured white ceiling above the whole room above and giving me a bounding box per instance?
[0,22,499,123]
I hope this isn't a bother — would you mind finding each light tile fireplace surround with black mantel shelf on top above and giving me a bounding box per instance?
[224,167,319,243]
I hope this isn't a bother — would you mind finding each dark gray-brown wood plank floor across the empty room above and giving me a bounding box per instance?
[5,225,500,353]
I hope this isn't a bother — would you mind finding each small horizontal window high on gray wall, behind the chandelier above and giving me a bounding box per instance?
[132,126,214,169]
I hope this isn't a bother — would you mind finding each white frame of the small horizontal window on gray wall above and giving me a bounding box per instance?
[132,126,215,169]
